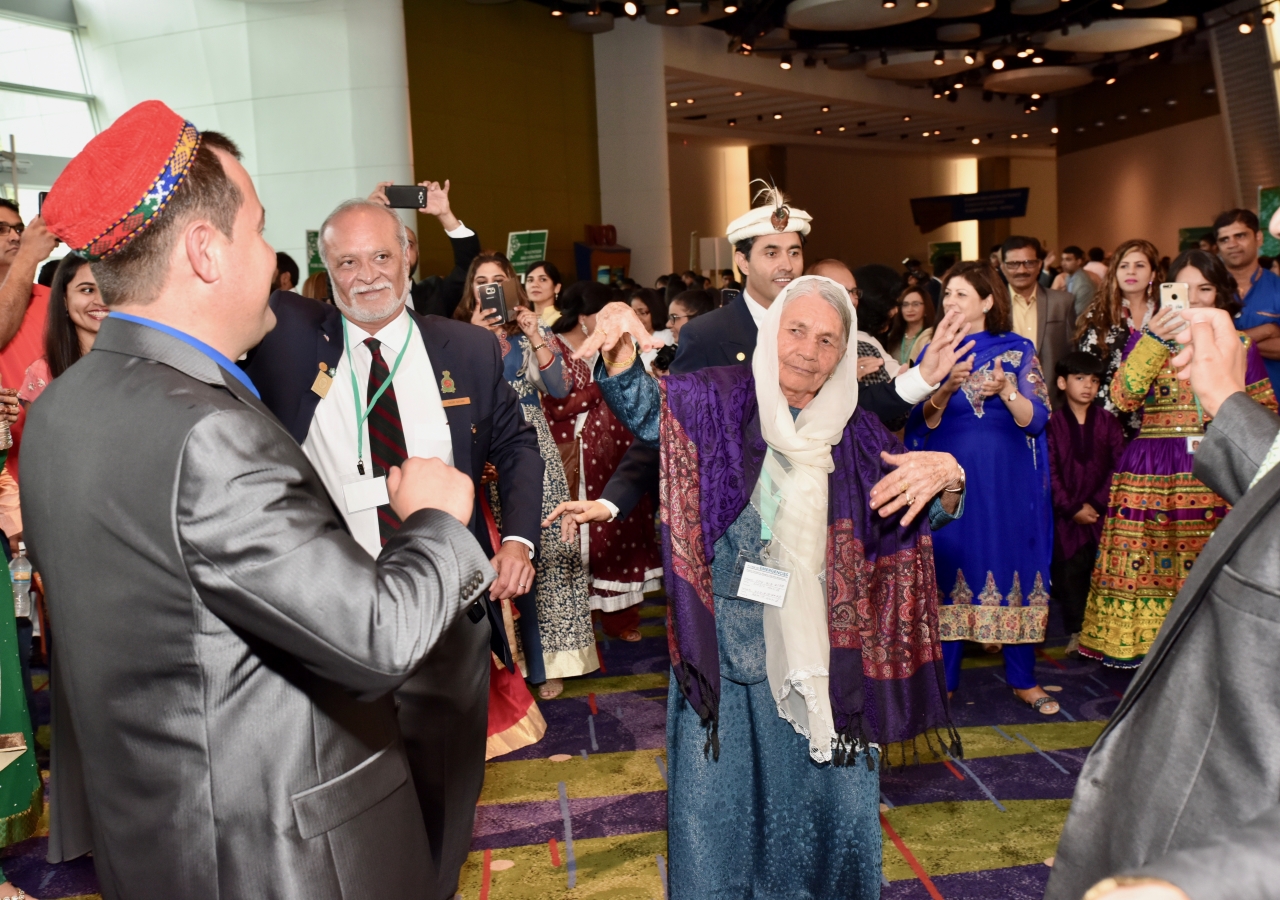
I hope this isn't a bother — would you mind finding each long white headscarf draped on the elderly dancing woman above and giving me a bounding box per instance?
[751,275,858,763]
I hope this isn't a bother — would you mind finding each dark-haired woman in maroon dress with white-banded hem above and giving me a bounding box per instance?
[543,285,660,641]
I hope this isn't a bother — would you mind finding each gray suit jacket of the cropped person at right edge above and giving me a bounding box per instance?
[1044,393,1280,900]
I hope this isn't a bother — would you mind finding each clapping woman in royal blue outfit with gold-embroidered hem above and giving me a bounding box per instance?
[906,262,1059,716]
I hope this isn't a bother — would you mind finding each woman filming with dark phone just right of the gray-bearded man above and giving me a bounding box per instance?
[454,253,600,700]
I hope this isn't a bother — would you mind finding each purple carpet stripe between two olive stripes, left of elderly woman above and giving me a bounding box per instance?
[471,791,667,850]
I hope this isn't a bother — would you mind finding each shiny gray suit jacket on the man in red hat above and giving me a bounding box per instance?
[22,319,493,900]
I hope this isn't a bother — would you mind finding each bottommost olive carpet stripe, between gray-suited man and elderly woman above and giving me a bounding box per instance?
[458,831,667,900]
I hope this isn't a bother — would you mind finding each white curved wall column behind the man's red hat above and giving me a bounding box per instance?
[74,0,413,271]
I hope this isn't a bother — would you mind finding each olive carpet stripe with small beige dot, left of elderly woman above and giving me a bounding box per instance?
[480,741,670,803]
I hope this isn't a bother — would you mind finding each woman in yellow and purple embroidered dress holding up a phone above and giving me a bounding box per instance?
[1080,250,1276,668]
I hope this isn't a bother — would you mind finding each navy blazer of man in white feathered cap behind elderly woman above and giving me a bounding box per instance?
[600,294,911,518]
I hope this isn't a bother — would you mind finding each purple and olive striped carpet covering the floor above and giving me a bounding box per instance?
[0,599,1130,900]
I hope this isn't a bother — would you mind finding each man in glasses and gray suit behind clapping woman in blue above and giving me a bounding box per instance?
[1000,234,1075,408]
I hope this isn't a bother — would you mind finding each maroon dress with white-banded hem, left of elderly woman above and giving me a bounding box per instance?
[543,334,662,632]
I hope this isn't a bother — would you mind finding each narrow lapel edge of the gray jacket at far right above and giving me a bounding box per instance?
[1098,458,1280,741]
